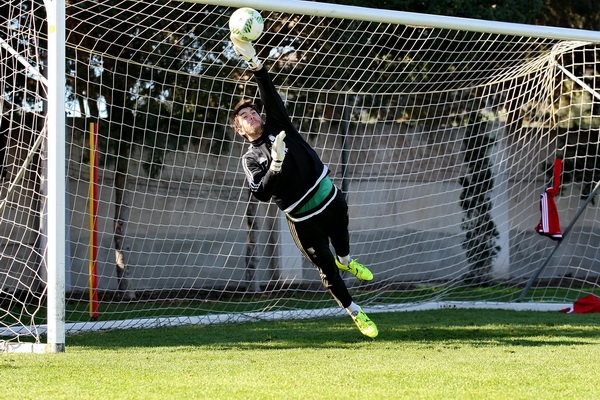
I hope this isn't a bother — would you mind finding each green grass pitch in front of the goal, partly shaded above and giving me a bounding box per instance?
[0,309,600,399]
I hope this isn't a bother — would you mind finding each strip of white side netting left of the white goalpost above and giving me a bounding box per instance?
[0,0,46,346]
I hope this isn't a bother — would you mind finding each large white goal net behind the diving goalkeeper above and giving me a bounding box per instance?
[0,0,600,350]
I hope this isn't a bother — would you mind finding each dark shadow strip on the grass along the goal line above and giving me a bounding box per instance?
[67,309,600,350]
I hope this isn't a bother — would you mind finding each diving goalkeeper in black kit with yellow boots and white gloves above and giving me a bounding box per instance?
[231,38,378,338]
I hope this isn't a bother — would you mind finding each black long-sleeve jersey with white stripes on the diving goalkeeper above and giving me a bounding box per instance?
[242,67,337,220]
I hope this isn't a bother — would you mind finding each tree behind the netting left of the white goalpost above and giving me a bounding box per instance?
[0,0,47,292]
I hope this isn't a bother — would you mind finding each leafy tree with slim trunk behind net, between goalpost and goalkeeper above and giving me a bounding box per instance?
[67,0,235,299]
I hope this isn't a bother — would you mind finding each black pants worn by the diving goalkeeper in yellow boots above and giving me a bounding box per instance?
[288,190,352,308]
